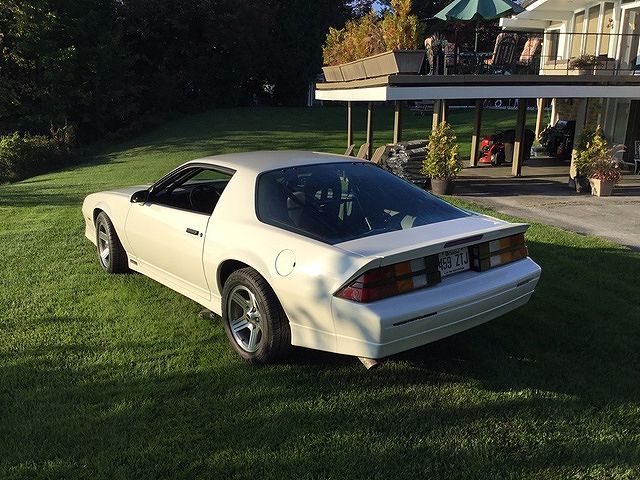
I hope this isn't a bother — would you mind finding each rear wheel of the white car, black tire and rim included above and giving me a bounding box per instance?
[222,268,291,364]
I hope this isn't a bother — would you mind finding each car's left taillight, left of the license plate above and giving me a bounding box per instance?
[335,255,441,303]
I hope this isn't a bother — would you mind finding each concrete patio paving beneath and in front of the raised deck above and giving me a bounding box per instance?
[455,159,640,251]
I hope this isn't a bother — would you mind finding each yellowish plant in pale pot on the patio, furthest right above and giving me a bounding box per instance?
[575,127,624,197]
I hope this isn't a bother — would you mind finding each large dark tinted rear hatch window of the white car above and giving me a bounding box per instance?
[256,162,470,244]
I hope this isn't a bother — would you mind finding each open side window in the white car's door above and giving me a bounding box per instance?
[151,167,233,215]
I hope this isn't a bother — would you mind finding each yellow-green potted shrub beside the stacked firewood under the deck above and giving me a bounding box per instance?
[421,122,462,195]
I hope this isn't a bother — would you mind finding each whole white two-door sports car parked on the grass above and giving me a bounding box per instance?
[82,151,540,363]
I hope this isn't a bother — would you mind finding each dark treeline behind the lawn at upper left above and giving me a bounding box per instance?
[0,0,353,141]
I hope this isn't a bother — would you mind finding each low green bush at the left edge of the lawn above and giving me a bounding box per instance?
[0,126,74,183]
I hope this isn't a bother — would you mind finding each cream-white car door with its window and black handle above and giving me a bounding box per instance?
[125,166,231,299]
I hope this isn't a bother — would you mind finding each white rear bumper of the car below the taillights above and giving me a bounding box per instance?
[332,258,541,358]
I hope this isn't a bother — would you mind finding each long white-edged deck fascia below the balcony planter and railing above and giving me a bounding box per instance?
[316,75,640,102]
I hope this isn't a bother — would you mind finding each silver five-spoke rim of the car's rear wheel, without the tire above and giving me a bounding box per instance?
[226,285,263,353]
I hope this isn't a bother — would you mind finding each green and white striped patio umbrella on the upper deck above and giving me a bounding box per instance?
[435,0,525,52]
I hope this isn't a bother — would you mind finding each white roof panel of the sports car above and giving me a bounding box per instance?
[185,150,366,175]
